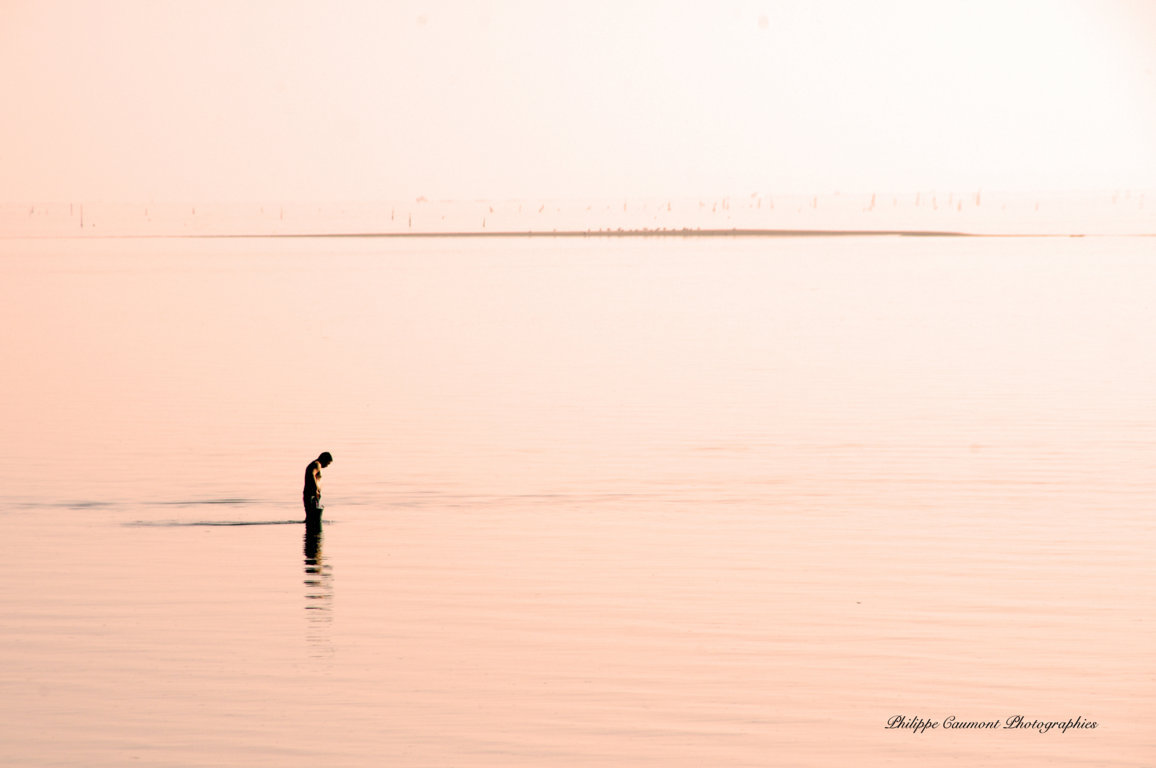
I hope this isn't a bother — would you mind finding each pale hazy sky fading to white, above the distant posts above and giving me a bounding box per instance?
[0,0,1156,201]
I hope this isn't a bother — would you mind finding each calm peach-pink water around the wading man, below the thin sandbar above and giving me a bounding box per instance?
[0,238,1156,768]
